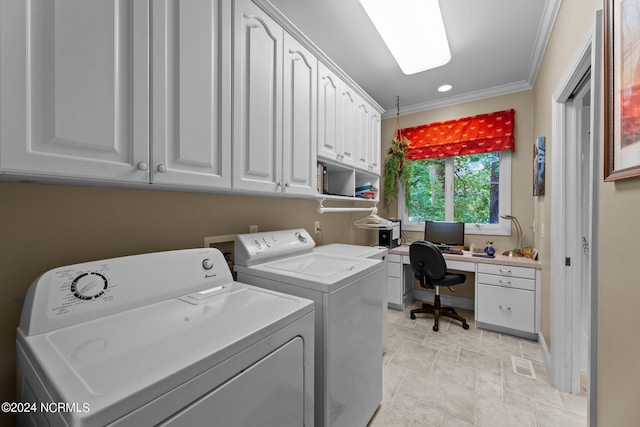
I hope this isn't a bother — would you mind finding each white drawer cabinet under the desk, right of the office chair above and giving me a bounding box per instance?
[476,264,538,339]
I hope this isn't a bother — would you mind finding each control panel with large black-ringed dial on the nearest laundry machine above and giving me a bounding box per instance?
[20,248,233,335]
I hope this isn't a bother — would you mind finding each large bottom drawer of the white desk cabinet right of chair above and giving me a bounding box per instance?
[476,285,535,333]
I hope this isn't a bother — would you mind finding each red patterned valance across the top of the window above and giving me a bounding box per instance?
[399,110,515,160]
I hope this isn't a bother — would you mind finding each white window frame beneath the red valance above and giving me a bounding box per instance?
[398,150,512,236]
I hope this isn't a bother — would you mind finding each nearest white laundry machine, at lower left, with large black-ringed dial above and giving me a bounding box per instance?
[17,249,314,427]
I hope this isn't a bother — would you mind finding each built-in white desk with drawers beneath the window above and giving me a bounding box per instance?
[387,245,541,340]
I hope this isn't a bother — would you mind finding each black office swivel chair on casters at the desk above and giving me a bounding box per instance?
[409,240,469,332]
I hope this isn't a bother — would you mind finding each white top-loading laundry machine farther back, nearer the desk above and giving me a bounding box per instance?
[234,229,386,427]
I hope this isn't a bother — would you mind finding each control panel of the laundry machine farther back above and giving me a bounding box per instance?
[233,228,316,267]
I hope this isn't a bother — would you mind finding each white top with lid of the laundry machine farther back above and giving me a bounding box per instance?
[235,253,382,292]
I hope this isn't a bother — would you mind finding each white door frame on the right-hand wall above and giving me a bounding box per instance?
[549,11,602,425]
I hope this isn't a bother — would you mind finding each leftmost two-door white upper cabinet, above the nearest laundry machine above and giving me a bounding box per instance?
[0,0,231,189]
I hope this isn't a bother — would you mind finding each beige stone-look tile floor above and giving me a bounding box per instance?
[369,302,587,427]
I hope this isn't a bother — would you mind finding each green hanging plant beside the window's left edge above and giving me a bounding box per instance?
[382,132,411,208]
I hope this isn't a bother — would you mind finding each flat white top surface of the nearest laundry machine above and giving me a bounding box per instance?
[18,282,313,425]
